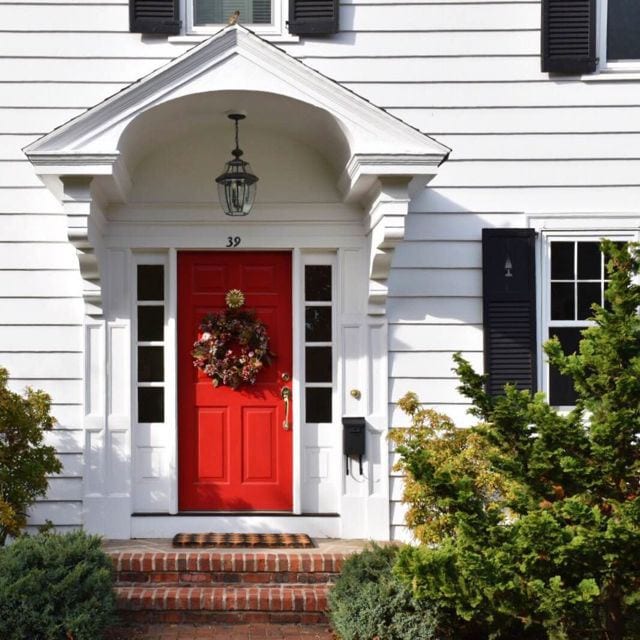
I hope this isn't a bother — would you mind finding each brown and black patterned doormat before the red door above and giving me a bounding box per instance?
[173,533,313,549]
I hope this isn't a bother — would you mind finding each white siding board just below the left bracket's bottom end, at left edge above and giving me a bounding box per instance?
[0,326,82,350]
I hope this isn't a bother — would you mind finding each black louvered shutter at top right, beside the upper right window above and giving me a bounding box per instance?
[542,0,597,74]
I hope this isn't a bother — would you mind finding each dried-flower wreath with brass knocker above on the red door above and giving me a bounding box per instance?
[191,289,273,389]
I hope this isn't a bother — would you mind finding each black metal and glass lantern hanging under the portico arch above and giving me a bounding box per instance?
[216,113,258,216]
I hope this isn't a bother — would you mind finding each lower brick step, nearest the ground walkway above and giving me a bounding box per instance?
[116,585,329,624]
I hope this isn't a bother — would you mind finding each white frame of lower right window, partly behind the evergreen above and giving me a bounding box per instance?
[538,229,637,411]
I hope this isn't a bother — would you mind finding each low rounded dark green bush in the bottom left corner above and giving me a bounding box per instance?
[0,531,115,640]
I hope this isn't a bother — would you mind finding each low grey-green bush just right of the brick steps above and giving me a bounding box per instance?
[329,545,441,640]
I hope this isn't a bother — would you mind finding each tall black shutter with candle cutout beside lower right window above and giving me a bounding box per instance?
[482,229,537,395]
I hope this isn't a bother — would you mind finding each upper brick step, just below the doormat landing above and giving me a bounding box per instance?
[111,552,345,587]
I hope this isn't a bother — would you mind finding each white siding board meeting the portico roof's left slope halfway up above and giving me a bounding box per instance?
[0,82,127,109]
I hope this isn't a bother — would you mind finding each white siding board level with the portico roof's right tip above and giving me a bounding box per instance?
[438,132,640,164]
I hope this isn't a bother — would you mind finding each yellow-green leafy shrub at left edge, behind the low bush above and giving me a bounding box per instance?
[0,367,62,546]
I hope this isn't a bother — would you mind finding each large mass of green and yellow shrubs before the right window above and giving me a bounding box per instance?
[394,242,640,640]
